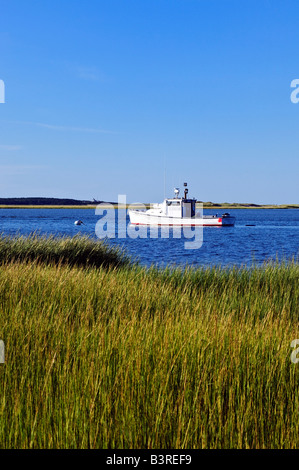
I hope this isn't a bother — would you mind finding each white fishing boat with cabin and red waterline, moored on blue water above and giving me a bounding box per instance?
[128,183,236,227]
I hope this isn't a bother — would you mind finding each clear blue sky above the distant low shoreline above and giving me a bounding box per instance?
[0,0,299,204]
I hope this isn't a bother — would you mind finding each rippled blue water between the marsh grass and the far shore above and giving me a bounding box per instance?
[0,209,299,266]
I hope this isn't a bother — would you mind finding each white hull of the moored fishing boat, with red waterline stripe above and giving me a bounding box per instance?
[129,210,235,227]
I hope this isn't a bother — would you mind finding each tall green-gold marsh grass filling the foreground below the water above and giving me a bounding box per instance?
[0,236,299,449]
